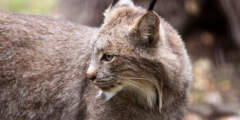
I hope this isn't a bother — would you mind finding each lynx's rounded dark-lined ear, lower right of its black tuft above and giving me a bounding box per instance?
[130,11,160,48]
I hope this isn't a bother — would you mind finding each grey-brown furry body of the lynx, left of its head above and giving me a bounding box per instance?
[0,13,97,120]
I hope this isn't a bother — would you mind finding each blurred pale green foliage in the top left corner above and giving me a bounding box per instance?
[0,0,57,15]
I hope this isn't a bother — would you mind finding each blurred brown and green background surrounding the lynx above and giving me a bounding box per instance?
[0,0,240,120]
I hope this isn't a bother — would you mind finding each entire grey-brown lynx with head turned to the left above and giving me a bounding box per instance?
[0,0,193,120]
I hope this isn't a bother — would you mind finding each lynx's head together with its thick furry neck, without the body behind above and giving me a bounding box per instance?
[87,0,192,120]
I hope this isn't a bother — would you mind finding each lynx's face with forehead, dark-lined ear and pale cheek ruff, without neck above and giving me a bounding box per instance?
[87,1,164,106]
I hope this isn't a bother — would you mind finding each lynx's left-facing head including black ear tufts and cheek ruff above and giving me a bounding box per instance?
[87,0,192,109]
